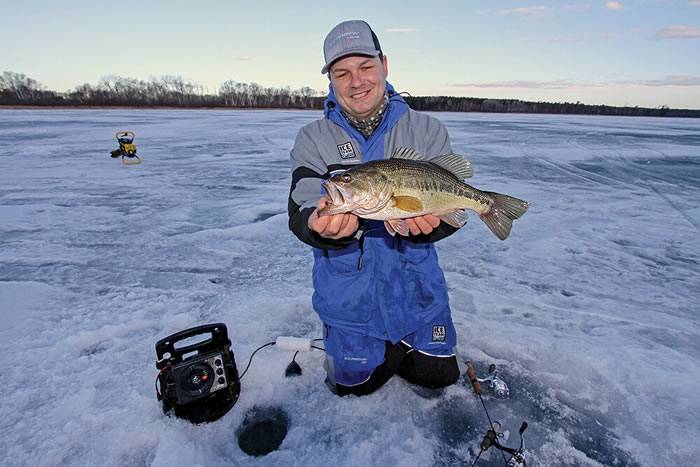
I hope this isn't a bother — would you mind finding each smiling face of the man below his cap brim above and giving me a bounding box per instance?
[329,55,388,120]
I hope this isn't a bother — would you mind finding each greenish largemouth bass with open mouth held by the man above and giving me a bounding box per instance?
[318,148,528,240]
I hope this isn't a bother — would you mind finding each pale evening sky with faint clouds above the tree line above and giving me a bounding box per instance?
[0,0,700,109]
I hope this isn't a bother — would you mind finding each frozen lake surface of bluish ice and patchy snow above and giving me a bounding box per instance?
[0,109,700,466]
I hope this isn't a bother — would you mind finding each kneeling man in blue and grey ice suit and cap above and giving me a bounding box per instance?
[289,21,460,396]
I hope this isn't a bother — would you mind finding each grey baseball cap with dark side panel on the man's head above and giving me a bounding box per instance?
[321,20,382,75]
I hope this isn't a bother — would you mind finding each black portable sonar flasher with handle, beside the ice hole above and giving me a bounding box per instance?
[156,323,241,423]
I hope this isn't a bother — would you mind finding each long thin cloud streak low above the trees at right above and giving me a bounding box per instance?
[451,75,700,89]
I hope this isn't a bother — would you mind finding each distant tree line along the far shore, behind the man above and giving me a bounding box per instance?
[0,71,700,118]
